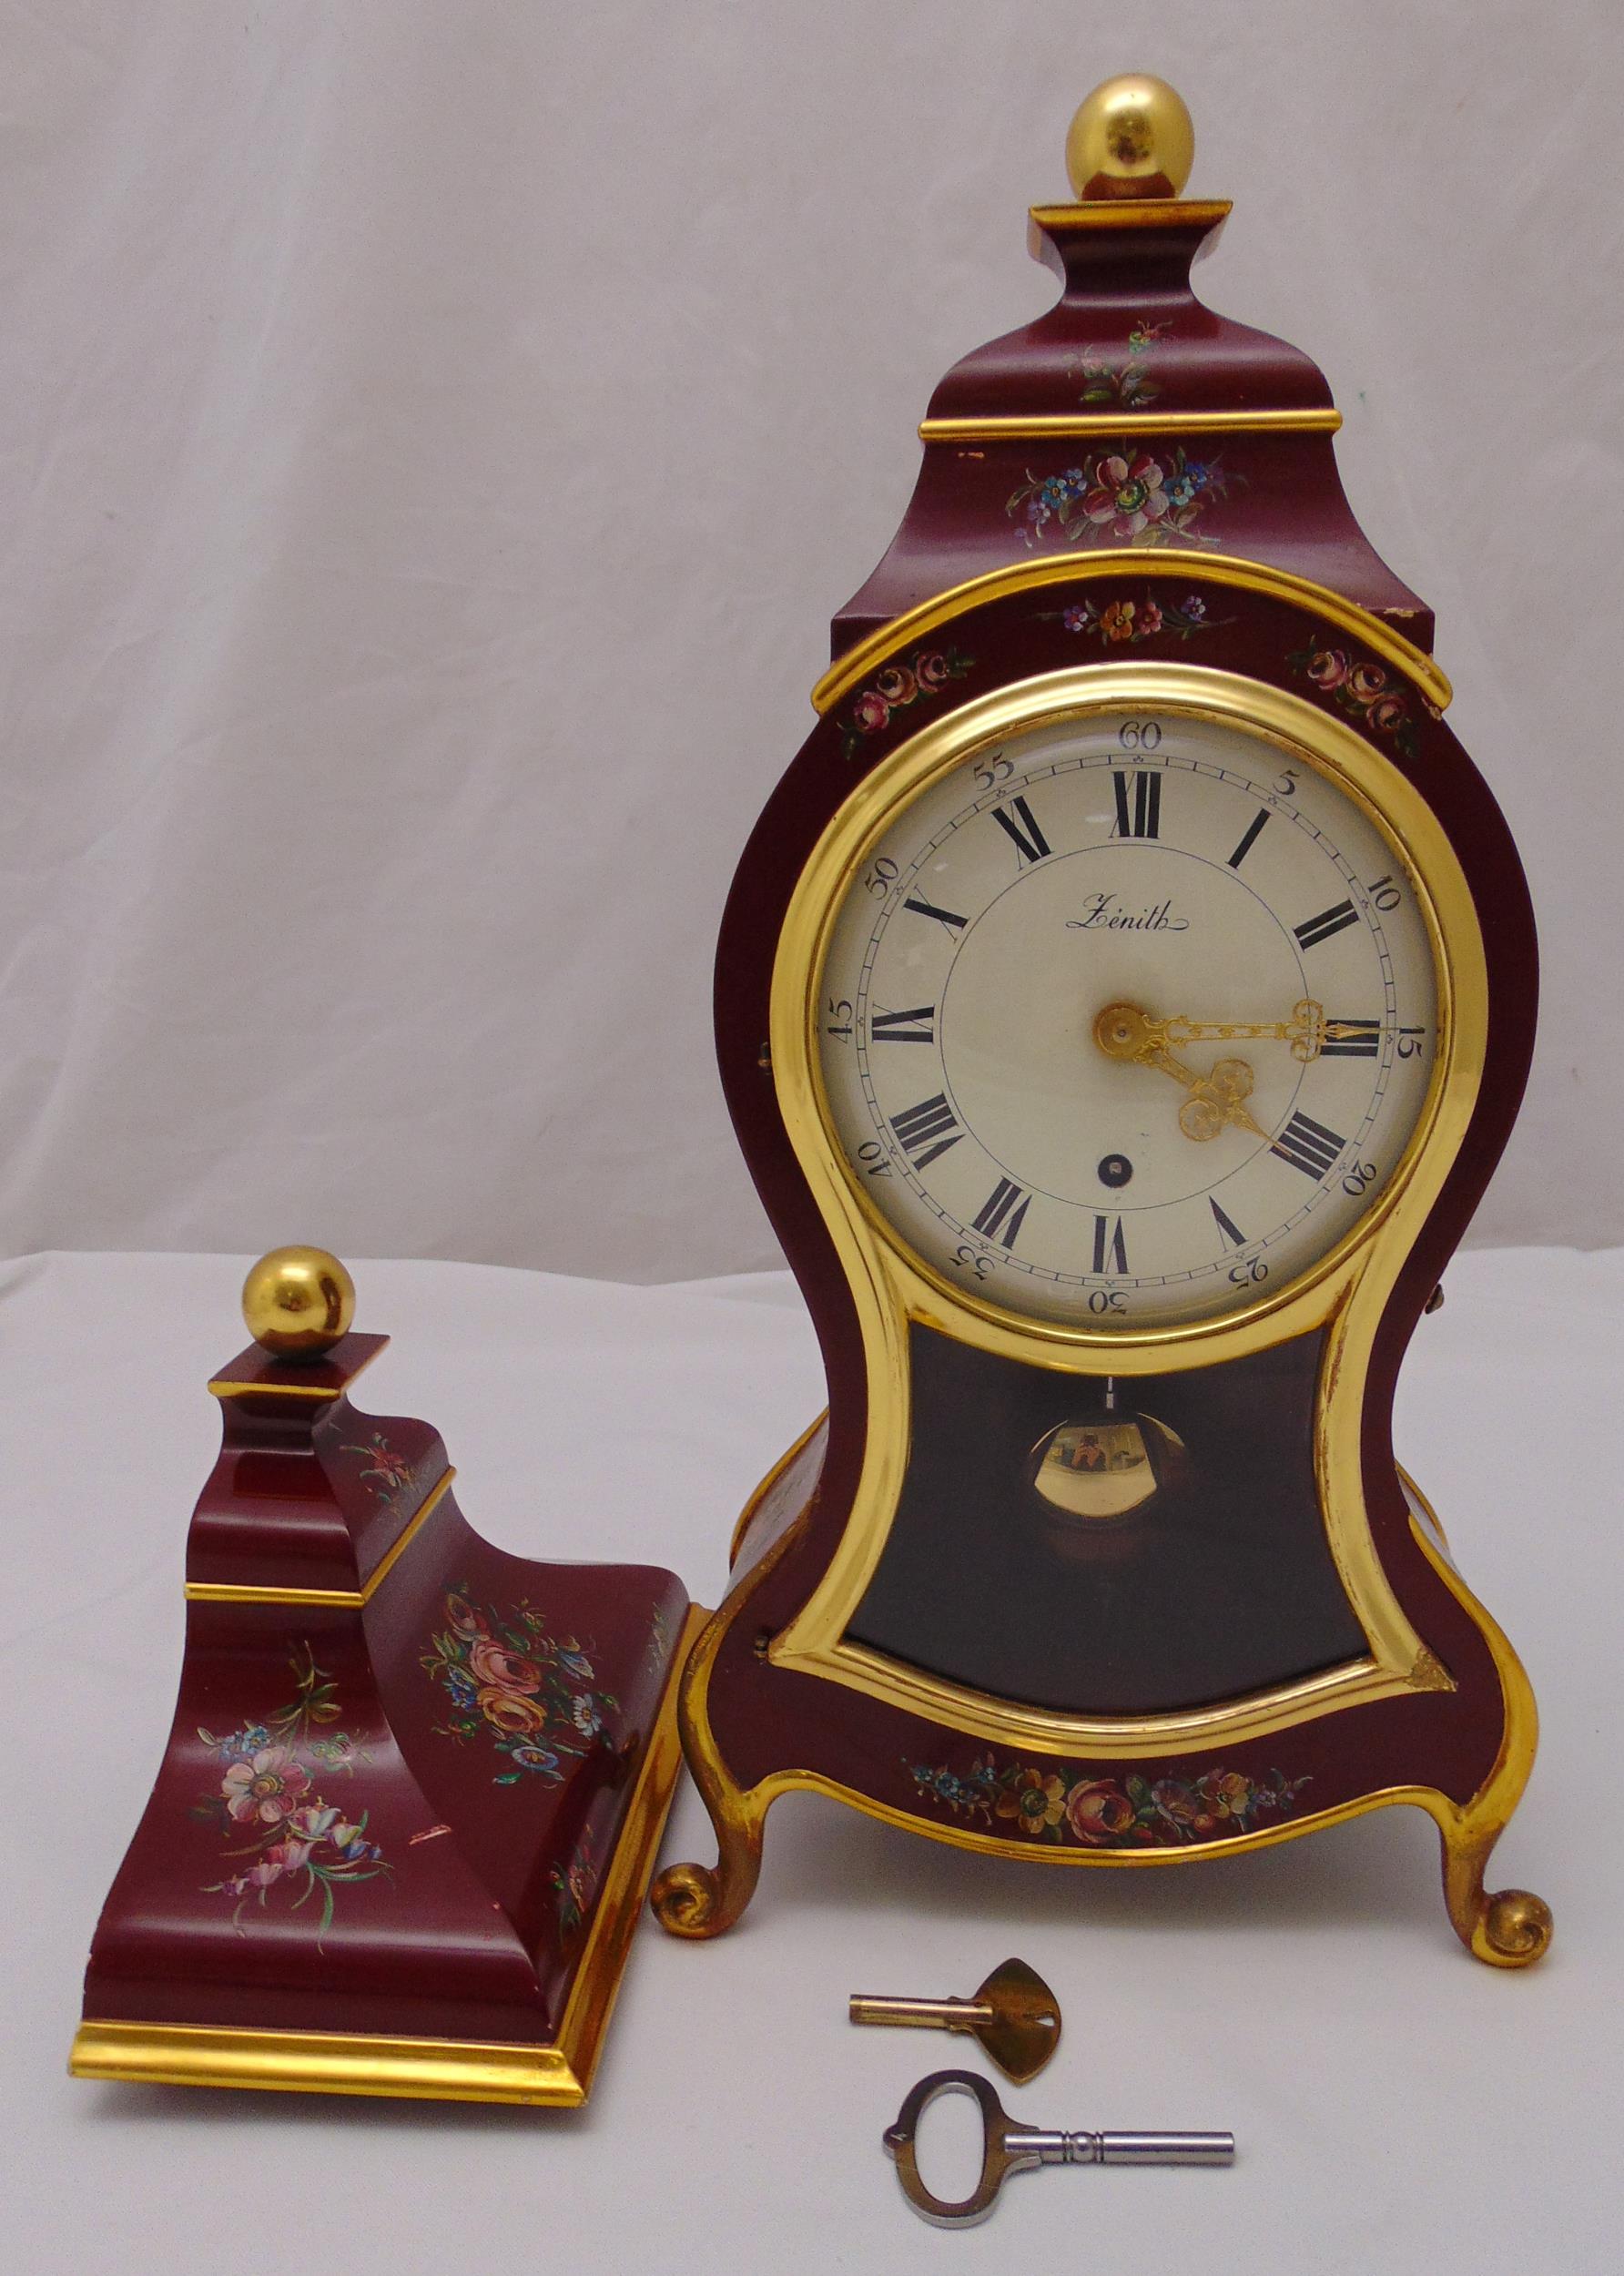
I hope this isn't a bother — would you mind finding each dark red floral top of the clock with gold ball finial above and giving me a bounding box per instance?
[832,73,1433,658]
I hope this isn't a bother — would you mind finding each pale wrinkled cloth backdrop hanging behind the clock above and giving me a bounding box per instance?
[0,0,1624,1279]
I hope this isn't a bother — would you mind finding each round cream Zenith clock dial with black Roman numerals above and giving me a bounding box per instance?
[818,708,1437,1329]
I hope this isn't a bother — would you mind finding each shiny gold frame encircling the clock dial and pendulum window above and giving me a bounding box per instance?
[769,651,1487,1760]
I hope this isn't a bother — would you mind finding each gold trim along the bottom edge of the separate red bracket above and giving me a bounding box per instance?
[68,1605,710,2108]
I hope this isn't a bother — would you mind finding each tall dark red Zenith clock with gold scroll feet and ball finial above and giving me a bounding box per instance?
[655,80,1549,1966]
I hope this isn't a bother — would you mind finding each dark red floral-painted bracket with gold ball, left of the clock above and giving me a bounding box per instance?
[73,1252,689,2103]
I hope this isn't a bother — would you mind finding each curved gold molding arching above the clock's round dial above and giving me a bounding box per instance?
[812,546,1454,713]
